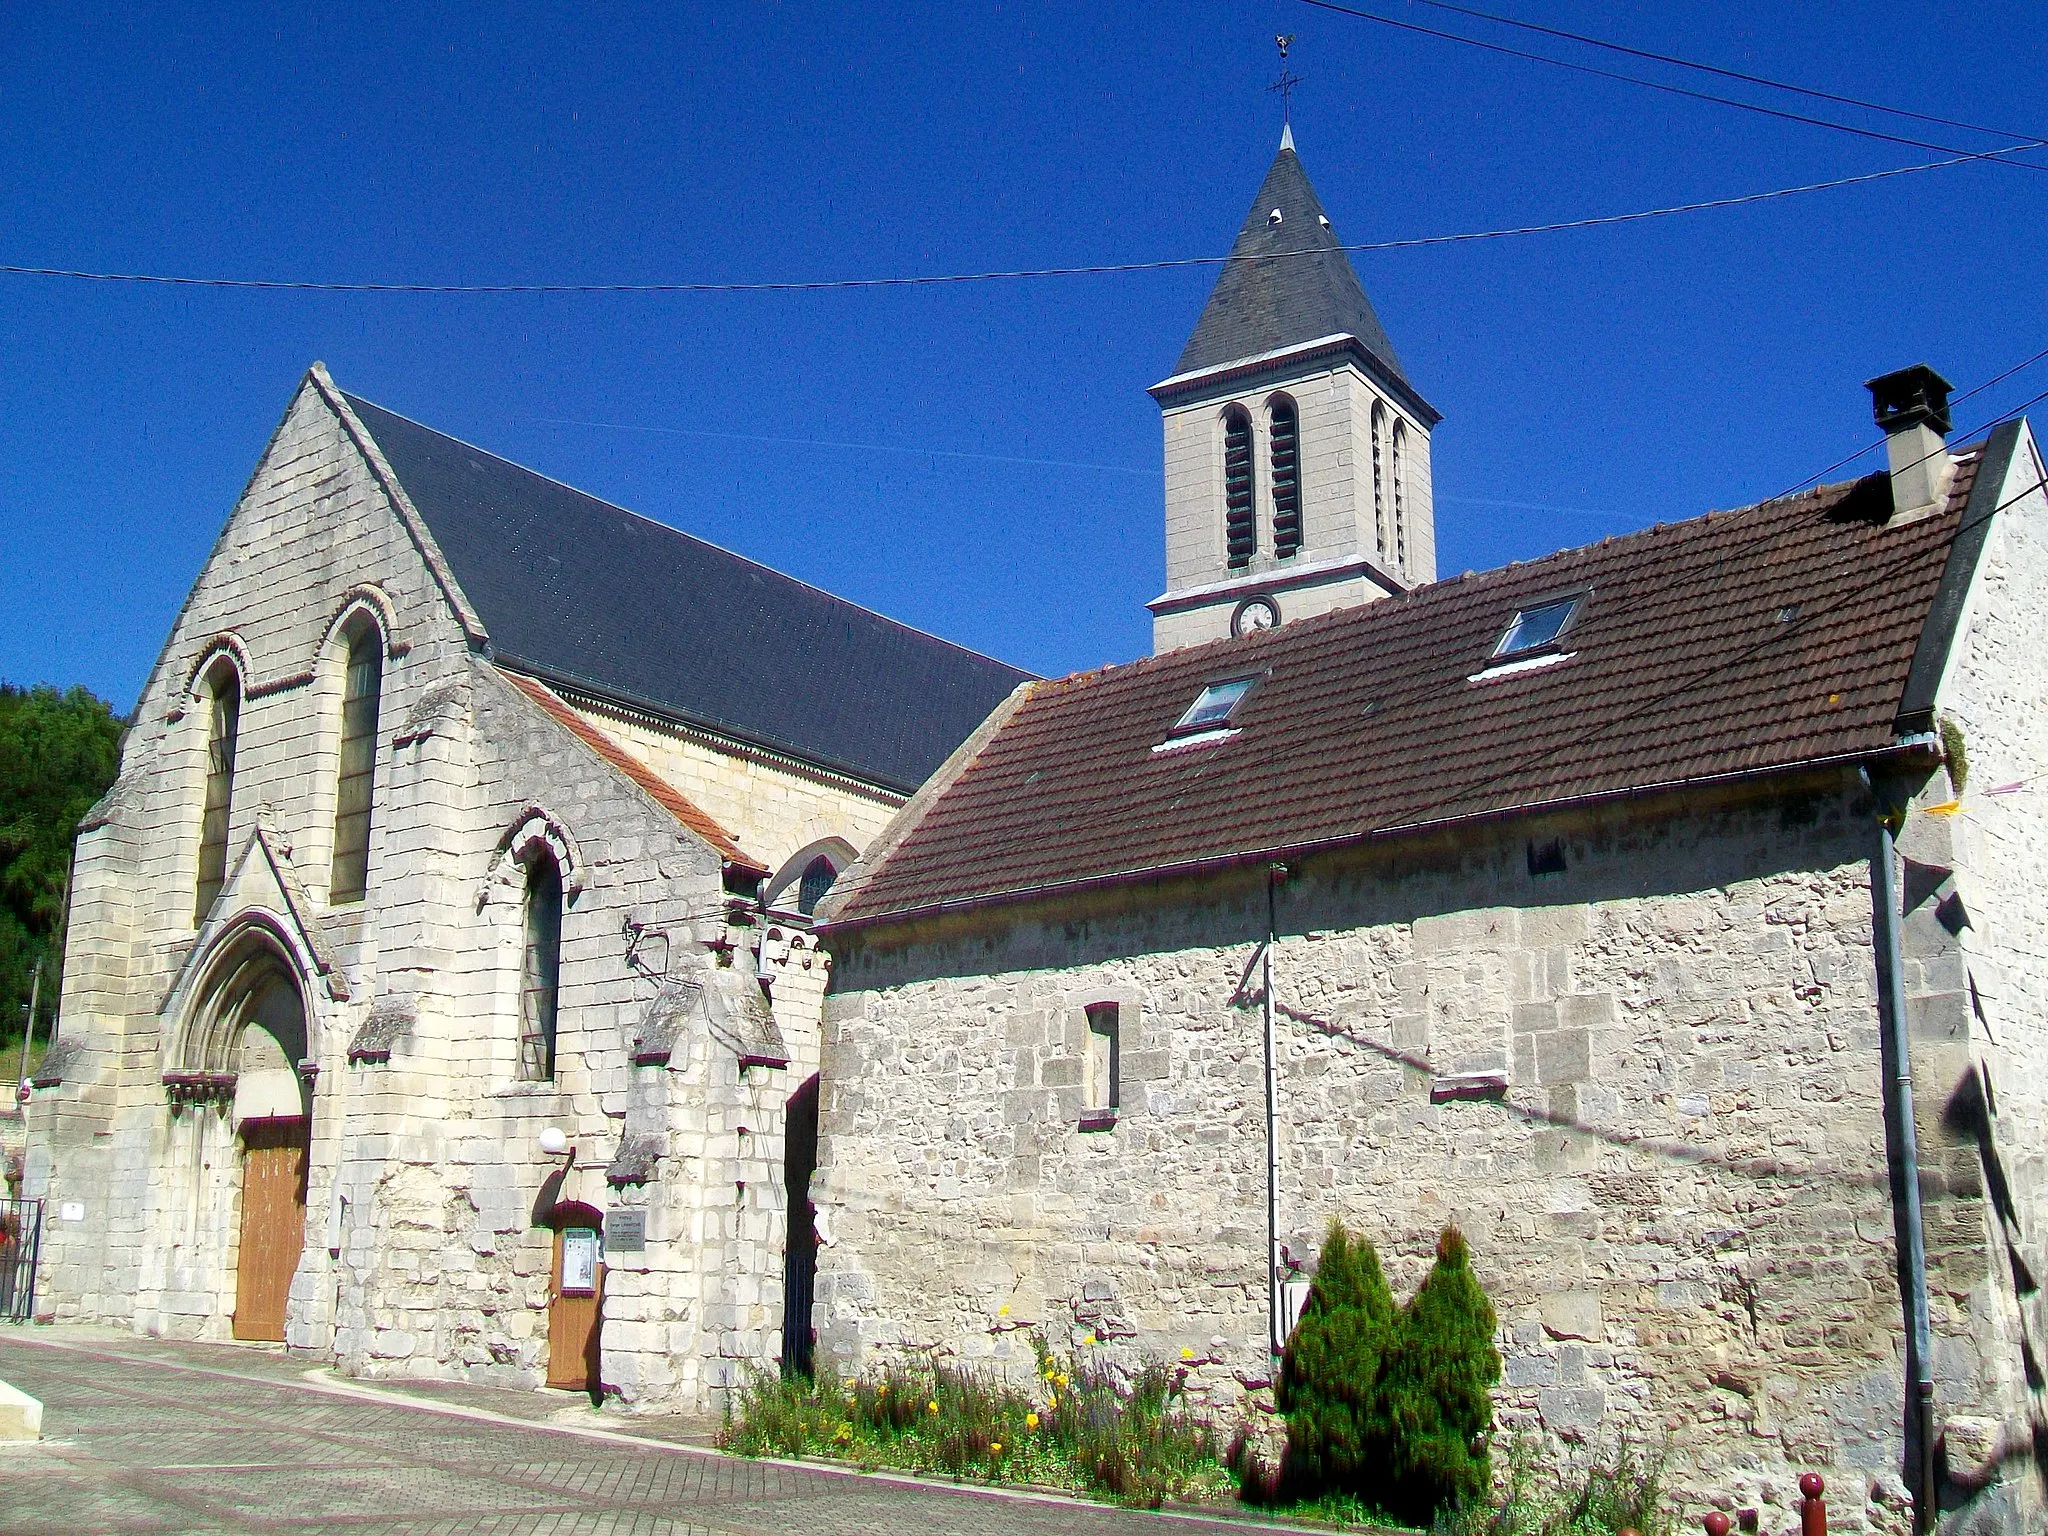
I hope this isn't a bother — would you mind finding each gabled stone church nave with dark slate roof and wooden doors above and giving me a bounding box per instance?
[29,365,1022,1409]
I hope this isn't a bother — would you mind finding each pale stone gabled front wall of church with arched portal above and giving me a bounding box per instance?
[33,376,823,1409]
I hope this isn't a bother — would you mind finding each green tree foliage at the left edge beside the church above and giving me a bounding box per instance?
[0,682,121,1040]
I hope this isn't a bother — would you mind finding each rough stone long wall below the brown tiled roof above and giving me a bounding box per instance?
[815,778,1972,1528]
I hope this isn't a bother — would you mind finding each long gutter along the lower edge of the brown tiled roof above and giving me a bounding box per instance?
[813,735,1939,936]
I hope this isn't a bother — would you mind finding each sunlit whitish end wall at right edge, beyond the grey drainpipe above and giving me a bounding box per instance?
[1901,432,2048,1524]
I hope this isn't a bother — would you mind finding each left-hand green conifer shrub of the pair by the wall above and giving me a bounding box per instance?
[1276,1221,1395,1501]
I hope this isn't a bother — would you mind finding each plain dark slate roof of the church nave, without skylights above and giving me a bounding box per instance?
[344,395,1030,793]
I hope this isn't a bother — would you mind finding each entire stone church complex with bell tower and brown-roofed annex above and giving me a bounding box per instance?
[29,135,2048,1530]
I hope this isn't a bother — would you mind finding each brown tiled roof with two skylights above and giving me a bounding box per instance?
[819,438,2011,930]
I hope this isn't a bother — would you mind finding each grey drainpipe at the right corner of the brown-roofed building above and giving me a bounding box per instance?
[1862,768,1935,1534]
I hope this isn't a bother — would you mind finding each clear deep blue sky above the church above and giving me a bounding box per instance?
[0,0,2048,709]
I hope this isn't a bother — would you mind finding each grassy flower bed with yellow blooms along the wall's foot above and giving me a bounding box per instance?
[719,1341,1233,1507]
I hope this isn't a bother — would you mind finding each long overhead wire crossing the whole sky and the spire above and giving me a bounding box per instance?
[0,143,2034,295]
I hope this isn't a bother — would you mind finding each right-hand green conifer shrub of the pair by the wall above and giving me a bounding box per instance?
[1370,1227,1501,1526]
